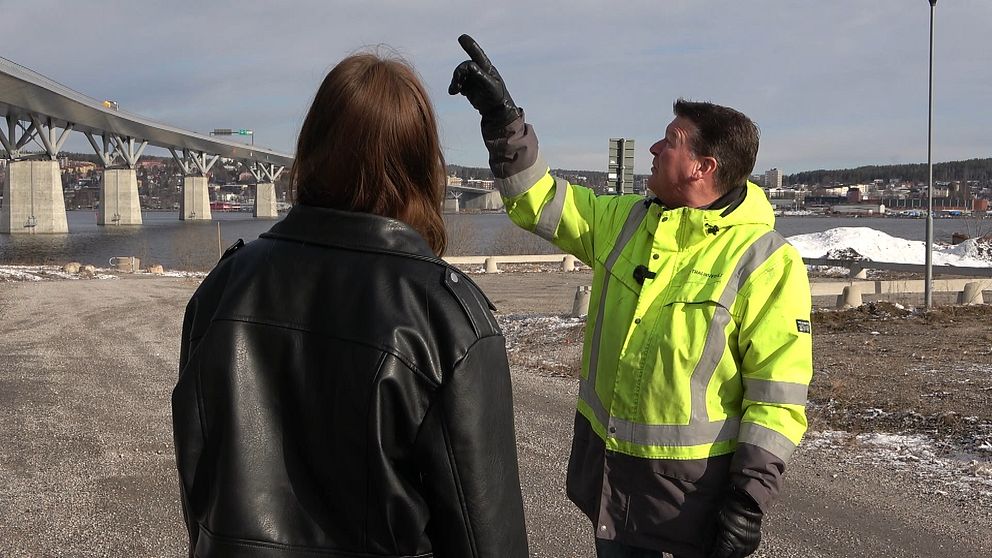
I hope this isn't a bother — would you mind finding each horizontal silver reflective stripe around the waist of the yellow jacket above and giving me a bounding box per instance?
[579,382,740,447]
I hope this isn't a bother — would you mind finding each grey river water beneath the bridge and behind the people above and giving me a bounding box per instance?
[0,211,992,270]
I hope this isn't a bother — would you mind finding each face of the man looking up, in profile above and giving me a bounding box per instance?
[648,116,699,207]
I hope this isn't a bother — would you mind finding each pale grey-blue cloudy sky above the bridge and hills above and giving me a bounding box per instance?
[0,0,992,178]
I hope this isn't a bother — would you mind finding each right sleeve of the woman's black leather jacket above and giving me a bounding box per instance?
[417,335,527,558]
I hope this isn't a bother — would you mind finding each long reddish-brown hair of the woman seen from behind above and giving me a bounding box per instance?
[291,53,447,256]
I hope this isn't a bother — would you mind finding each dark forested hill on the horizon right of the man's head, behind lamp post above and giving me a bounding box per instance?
[782,159,992,185]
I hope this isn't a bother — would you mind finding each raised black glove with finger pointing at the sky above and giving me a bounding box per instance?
[448,35,520,127]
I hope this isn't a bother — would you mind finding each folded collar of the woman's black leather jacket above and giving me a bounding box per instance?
[259,204,437,259]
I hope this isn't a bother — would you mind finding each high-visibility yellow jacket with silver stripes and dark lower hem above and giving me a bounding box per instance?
[486,119,812,553]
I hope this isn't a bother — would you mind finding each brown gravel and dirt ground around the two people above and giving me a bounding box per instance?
[0,272,992,557]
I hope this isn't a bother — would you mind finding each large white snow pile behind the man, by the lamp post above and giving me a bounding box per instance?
[788,227,992,267]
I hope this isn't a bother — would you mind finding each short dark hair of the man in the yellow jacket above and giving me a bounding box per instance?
[673,98,760,193]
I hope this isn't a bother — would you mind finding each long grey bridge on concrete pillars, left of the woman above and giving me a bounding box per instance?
[0,58,293,234]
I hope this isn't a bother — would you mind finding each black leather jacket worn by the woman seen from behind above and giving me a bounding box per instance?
[172,205,527,558]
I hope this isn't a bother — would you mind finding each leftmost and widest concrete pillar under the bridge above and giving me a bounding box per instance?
[0,161,69,234]
